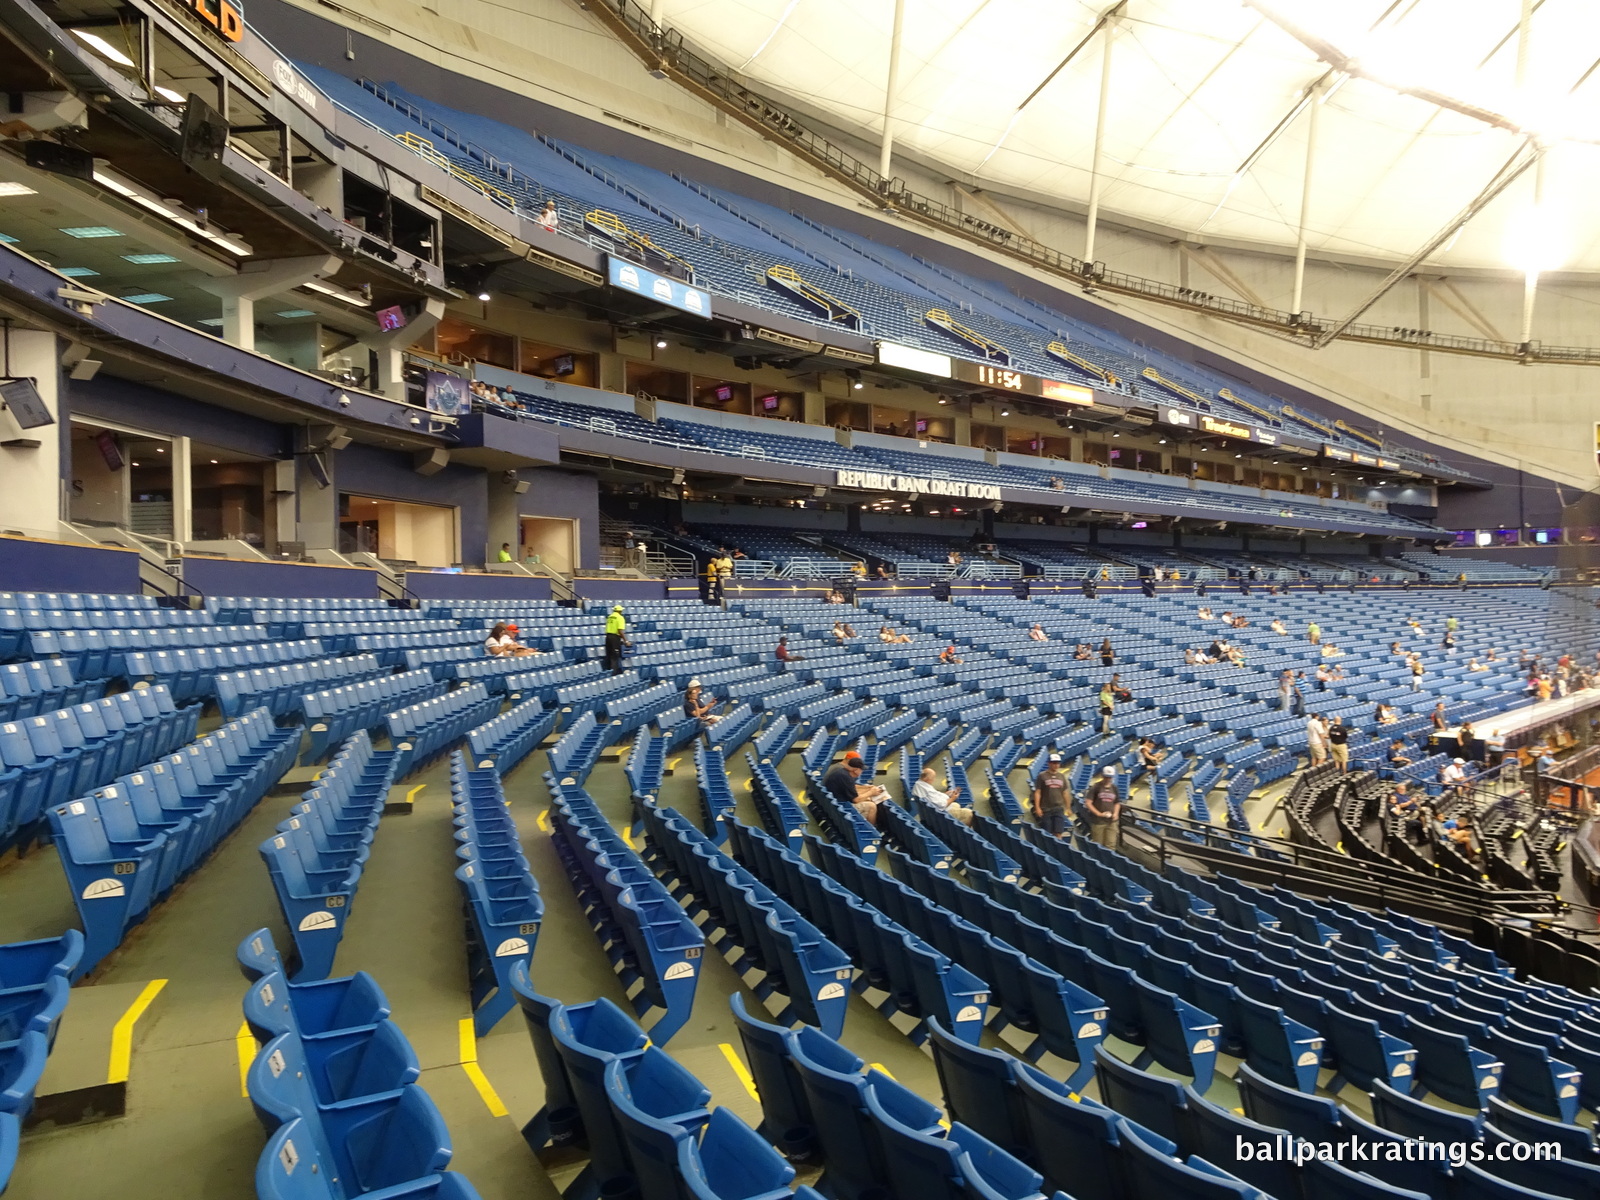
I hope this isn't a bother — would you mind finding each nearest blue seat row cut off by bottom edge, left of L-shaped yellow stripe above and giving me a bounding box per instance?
[238,930,477,1200]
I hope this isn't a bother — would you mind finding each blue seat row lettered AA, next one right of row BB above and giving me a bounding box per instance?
[544,773,706,1045]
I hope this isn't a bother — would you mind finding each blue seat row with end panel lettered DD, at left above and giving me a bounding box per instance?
[46,709,299,976]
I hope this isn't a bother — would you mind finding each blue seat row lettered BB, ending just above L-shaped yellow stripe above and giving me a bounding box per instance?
[450,754,544,1037]
